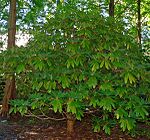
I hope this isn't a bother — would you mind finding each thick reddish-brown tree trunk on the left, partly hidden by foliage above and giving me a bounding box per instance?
[1,0,16,116]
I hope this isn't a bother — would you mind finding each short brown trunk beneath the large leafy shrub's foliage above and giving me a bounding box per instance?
[67,114,75,139]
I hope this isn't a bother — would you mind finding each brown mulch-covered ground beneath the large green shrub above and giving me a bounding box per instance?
[0,116,150,140]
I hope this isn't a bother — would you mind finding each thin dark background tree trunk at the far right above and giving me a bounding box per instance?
[137,0,142,46]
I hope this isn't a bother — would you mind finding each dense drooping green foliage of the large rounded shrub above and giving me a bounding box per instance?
[0,2,150,134]
